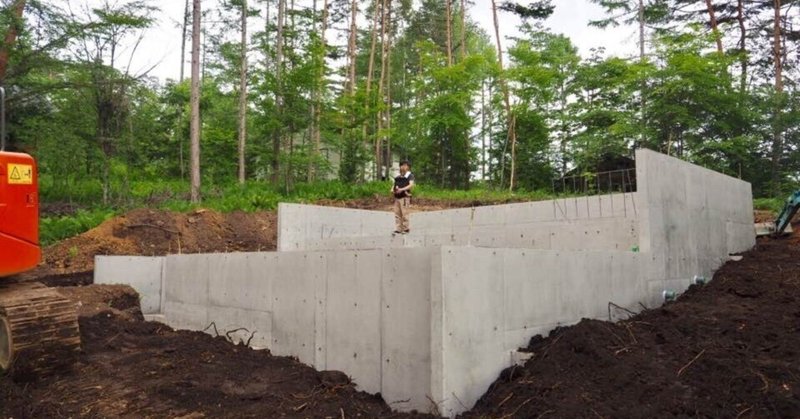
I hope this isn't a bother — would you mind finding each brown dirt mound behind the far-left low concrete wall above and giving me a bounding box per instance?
[26,209,277,285]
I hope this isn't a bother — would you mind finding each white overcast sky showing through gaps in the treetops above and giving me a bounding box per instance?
[95,0,636,80]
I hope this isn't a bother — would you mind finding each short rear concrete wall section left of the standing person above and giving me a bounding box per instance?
[278,204,394,252]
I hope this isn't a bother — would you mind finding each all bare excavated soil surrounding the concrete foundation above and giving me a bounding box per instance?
[0,206,800,419]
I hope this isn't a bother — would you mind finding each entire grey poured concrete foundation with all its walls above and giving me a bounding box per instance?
[96,150,755,416]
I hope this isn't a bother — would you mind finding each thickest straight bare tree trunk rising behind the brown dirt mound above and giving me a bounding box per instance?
[190,0,200,204]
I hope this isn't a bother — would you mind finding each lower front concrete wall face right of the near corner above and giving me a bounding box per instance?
[431,247,664,417]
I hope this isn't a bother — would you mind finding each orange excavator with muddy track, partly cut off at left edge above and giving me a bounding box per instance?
[0,87,80,380]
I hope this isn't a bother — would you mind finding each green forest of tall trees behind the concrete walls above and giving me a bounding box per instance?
[0,0,800,203]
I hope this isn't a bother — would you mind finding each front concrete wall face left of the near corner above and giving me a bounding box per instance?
[101,248,439,411]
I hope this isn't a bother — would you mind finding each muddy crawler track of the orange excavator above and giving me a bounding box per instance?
[0,282,81,381]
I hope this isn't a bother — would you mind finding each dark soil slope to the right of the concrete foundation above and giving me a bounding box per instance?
[462,239,800,418]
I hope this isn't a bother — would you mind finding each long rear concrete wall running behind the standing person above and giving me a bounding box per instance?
[278,193,640,250]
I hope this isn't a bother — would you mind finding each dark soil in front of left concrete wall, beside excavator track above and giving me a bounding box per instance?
[0,312,438,419]
